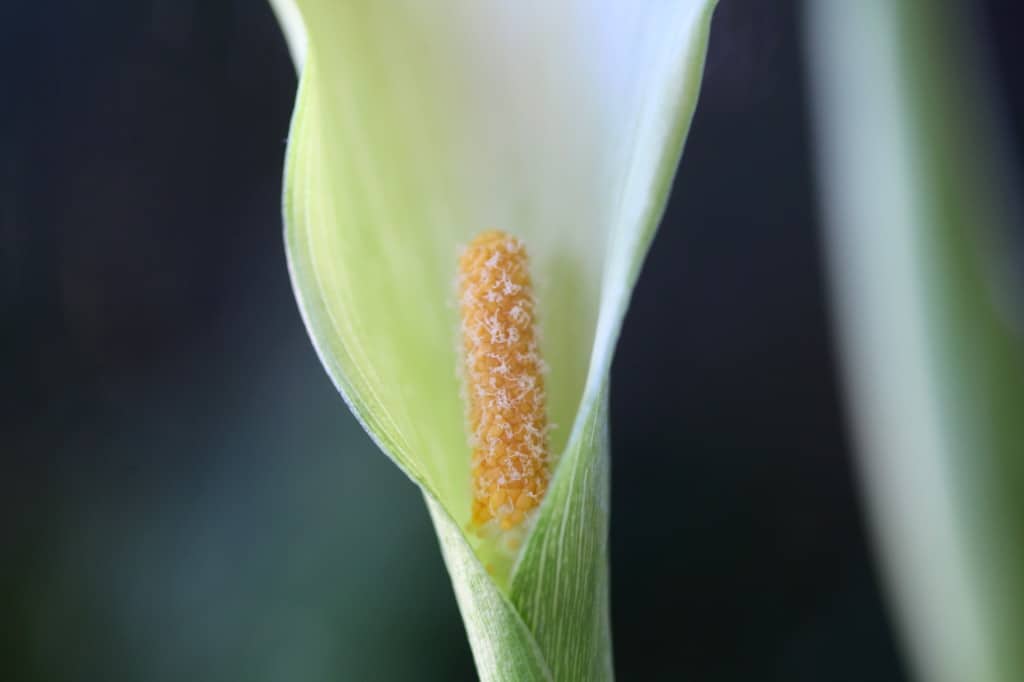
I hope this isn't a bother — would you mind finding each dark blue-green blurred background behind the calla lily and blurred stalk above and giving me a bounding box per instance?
[6,0,1024,682]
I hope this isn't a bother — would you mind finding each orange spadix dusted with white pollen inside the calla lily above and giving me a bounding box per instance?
[459,230,550,535]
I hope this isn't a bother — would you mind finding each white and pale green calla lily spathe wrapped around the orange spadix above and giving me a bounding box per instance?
[273,0,715,680]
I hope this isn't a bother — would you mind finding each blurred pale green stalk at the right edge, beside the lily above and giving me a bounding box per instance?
[807,0,1024,682]
